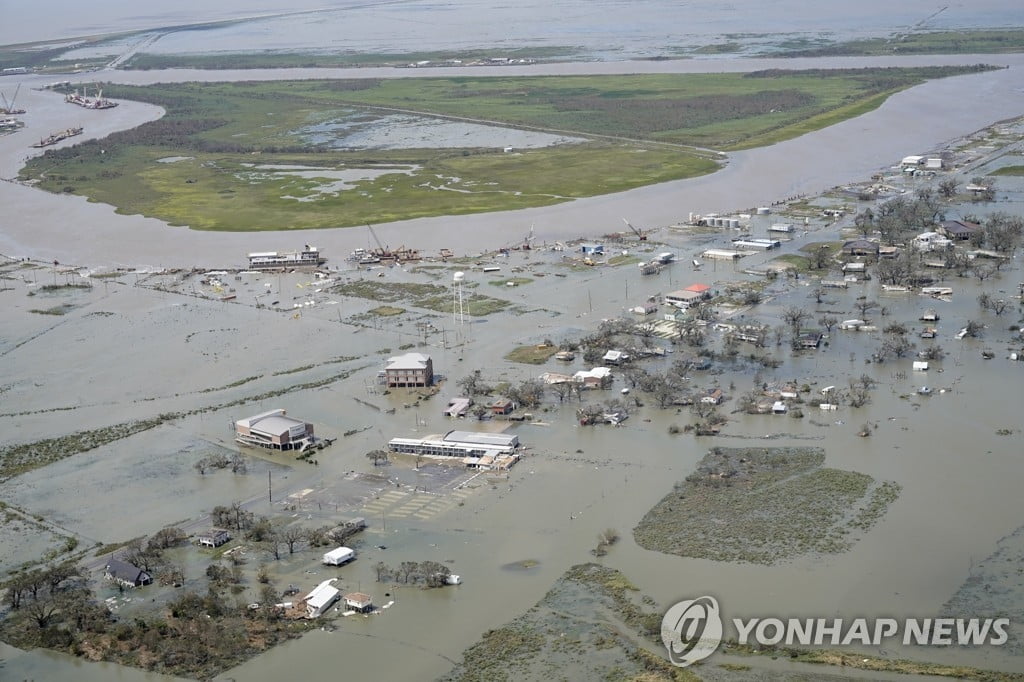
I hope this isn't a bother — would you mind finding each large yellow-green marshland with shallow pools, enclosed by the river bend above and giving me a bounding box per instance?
[20,67,991,231]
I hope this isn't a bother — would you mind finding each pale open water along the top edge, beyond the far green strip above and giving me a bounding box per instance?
[28,0,1020,59]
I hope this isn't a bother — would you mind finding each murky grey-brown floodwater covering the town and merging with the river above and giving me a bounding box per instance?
[0,11,1024,682]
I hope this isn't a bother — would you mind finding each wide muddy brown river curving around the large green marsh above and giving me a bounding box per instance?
[0,55,1024,267]
